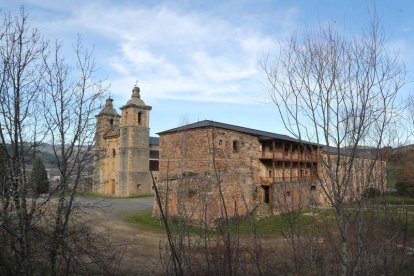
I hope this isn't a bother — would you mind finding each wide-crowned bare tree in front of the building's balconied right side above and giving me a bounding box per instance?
[263,15,405,275]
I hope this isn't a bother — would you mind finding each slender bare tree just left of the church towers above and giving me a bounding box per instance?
[43,37,107,274]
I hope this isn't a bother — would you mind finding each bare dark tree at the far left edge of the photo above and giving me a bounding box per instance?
[0,10,47,274]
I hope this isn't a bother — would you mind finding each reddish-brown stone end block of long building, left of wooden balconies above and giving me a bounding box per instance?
[154,127,260,221]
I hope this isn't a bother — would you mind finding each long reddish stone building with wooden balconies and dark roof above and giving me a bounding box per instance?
[154,121,384,221]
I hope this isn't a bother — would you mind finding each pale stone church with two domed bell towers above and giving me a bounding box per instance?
[93,86,159,196]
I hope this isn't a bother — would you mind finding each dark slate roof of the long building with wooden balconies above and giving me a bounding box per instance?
[157,120,316,145]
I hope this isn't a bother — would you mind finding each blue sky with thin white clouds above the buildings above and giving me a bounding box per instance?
[0,0,414,135]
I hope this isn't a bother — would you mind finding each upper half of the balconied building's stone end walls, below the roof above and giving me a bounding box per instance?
[160,127,260,178]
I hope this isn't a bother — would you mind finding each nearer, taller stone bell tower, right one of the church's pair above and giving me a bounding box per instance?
[119,86,152,196]
